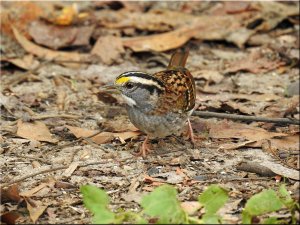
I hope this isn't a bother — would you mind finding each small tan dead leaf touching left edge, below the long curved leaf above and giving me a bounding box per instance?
[1,54,40,70]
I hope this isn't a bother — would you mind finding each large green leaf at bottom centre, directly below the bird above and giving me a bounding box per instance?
[141,185,187,224]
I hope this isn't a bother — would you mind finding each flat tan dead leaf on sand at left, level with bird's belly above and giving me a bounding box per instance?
[17,119,58,143]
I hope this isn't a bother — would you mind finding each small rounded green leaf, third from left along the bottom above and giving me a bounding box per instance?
[198,184,228,214]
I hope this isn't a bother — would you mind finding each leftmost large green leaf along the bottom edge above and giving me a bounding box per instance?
[80,185,115,224]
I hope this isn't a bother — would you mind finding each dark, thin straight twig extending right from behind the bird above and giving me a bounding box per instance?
[192,111,300,125]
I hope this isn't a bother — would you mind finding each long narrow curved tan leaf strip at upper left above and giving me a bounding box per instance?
[12,27,91,65]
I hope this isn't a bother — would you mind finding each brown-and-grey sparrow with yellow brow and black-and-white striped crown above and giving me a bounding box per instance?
[114,50,196,158]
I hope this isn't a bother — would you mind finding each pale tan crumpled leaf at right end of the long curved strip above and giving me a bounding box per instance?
[91,36,125,65]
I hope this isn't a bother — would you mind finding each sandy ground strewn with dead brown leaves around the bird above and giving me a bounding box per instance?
[0,2,299,224]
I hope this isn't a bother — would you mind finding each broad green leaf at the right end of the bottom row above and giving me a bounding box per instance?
[244,190,283,216]
